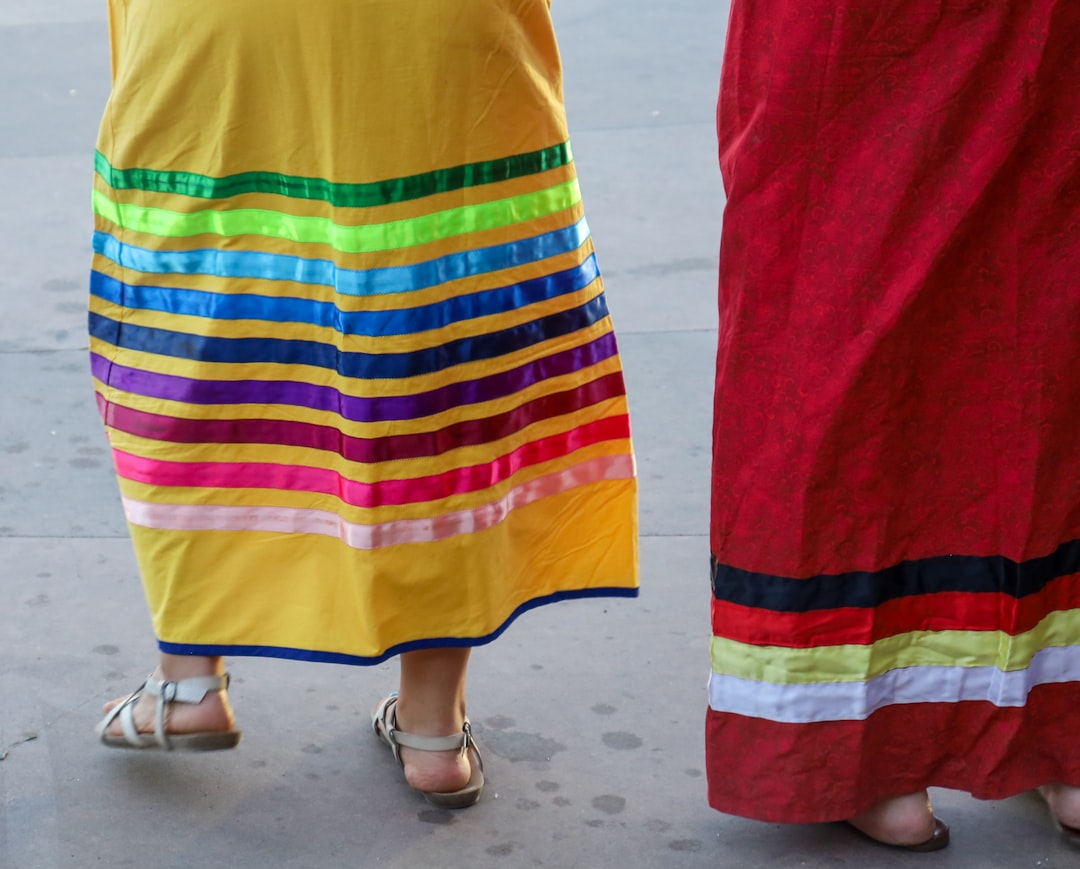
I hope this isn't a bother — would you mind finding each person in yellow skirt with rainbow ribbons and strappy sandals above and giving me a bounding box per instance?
[90,0,637,806]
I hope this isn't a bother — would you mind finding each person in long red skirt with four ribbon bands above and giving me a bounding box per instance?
[707,0,1080,851]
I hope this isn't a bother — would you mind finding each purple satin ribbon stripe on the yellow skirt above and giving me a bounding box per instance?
[91,332,618,422]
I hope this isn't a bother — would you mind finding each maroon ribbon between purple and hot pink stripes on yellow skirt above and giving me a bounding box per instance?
[97,371,624,464]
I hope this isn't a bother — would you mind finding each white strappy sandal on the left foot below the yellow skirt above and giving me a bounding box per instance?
[97,674,240,751]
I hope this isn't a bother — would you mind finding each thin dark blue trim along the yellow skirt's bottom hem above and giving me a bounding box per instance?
[158,587,638,667]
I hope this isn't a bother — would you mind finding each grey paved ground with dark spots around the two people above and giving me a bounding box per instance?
[0,0,1080,869]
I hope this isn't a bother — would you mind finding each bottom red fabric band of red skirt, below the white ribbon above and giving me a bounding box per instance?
[705,682,1080,824]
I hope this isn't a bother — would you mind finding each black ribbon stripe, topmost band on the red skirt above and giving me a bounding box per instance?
[712,540,1080,612]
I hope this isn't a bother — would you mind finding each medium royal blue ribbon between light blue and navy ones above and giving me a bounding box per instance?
[90,255,599,338]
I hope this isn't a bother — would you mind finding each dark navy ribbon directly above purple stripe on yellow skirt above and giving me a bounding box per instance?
[90,296,608,380]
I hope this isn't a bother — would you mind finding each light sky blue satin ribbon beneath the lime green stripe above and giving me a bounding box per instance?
[94,217,589,296]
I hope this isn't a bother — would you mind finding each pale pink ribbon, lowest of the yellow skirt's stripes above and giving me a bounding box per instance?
[124,454,635,549]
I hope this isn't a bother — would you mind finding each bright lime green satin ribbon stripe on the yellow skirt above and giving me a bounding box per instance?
[94,179,581,254]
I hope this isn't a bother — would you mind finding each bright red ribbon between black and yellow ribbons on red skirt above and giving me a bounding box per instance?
[713,573,1080,649]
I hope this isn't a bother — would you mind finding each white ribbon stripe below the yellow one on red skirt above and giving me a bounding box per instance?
[708,646,1080,724]
